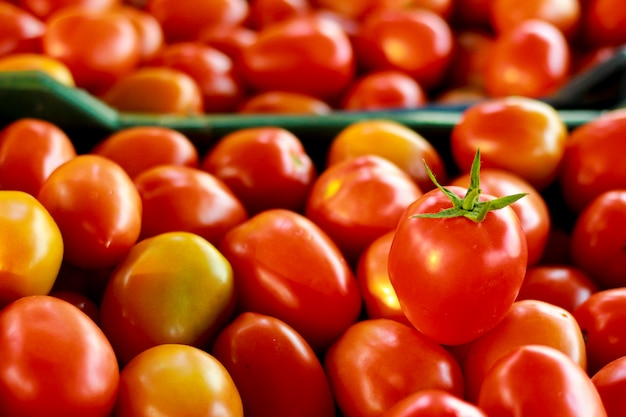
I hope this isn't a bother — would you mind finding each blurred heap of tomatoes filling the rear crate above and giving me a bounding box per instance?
[0,0,626,115]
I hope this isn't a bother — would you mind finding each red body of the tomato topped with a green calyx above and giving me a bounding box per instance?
[389,186,528,345]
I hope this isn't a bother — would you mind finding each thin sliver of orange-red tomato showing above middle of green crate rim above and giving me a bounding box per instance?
[238,91,333,114]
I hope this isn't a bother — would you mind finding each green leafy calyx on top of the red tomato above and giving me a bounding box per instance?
[413,149,527,223]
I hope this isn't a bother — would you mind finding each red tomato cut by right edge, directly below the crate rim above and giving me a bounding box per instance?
[559,109,626,213]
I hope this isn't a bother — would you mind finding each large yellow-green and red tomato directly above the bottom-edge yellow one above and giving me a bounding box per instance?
[100,232,234,364]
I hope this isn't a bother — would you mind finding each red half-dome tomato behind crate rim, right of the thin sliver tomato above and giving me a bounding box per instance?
[341,70,428,110]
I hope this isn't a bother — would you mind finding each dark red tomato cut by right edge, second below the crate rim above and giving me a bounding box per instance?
[570,190,626,288]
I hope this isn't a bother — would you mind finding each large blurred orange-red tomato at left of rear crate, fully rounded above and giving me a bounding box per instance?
[43,8,140,94]
